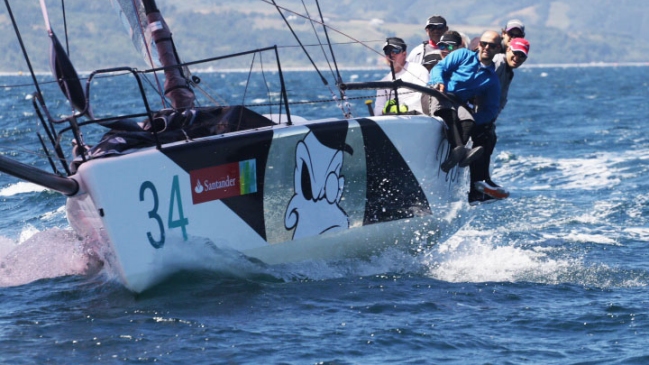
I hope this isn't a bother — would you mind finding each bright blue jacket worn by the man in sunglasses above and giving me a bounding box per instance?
[428,48,500,124]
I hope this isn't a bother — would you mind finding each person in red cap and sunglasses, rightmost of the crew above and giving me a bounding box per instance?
[469,38,530,203]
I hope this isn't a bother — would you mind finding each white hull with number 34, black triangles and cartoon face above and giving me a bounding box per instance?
[68,116,468,292]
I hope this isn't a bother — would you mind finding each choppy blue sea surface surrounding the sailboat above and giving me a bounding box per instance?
[0,66,649,364]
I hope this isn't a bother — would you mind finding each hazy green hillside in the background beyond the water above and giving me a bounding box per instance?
[0,0,649,71]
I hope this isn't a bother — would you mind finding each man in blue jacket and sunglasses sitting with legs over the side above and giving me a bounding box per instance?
[423,31,502,179]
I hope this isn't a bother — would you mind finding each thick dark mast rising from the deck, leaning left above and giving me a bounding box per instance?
[142,0,195,109]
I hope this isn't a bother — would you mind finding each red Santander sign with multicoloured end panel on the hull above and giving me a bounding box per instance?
[189,159,257,204]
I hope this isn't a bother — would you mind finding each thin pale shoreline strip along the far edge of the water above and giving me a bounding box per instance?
[0,61,649,76]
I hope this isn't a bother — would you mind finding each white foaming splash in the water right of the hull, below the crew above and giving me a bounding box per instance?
[422,229,649,289]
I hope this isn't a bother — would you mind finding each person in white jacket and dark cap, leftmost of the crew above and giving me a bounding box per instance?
[374,37,429,115]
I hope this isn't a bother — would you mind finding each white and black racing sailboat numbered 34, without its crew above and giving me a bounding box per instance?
[0,0,469,293]
